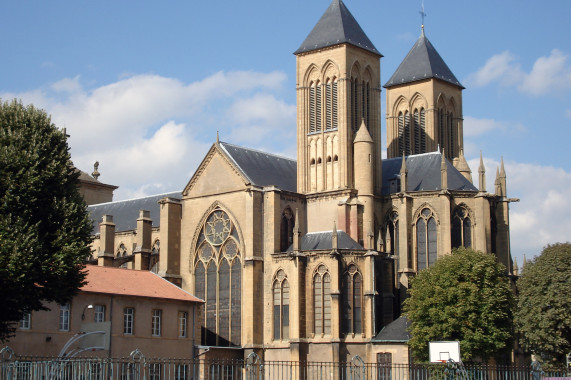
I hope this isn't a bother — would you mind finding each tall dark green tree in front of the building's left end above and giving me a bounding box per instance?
[0,100,91,341]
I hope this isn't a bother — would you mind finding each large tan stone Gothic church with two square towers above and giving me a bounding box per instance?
[89,0,513,363]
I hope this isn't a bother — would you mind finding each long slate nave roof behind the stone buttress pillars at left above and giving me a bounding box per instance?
[87,191,182,235]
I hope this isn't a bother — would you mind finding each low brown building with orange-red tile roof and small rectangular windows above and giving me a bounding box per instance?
[8,265,203,358]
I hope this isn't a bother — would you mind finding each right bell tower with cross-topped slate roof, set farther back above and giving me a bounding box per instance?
[384,26,464,161]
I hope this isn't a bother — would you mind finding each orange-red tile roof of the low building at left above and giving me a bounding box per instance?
[80,265,204,302]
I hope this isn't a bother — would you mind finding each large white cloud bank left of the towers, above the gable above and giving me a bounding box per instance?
[0,71,296,200]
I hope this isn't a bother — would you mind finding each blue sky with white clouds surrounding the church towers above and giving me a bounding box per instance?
[0,0,571,263]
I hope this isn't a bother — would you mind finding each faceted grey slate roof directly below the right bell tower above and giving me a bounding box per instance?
[382,152,478,195]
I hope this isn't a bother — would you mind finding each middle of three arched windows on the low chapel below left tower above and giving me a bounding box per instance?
[313,265,331,335]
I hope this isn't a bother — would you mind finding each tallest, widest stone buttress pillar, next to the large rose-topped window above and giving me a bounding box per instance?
[158,198,182,286]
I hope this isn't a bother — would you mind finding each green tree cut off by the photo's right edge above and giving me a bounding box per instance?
[515,243,571,363]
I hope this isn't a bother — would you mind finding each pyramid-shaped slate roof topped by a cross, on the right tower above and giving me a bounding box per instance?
[383,30,464,88]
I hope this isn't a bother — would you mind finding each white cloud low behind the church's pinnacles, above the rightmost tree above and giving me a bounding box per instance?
[469,159,571,268]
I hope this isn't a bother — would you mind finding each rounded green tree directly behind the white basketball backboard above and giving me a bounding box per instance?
[404,248,515,361]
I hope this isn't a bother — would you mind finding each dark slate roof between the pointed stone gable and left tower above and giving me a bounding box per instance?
[220,142,297,192]
